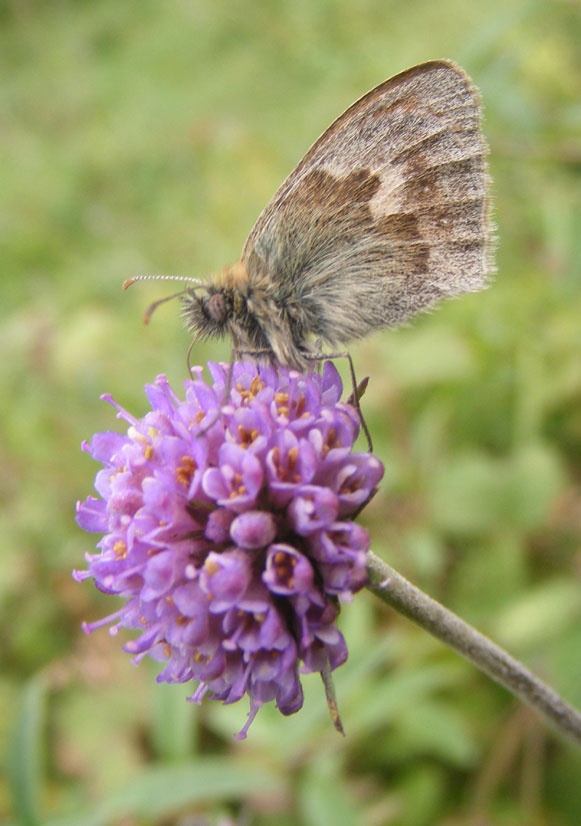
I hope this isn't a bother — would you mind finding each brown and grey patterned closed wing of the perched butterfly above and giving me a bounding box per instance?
[242,61,492,346]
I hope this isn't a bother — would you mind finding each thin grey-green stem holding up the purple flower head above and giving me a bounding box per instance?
[367,551,581,746]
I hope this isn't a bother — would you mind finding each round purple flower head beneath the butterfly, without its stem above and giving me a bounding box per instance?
[74,362,383,737]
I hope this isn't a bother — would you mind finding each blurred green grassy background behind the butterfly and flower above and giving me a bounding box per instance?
[0,0,581,826]
